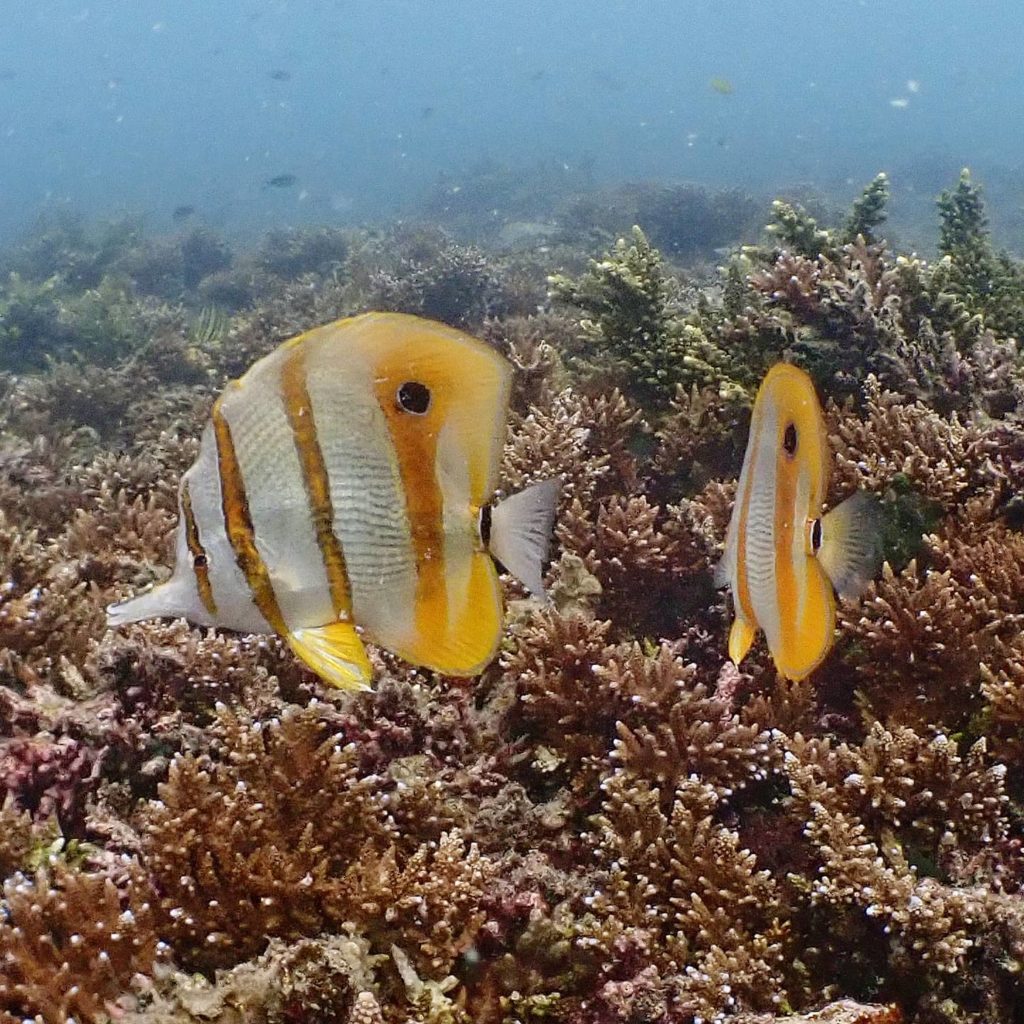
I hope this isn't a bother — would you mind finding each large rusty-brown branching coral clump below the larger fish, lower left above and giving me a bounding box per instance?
[142,712,389,967]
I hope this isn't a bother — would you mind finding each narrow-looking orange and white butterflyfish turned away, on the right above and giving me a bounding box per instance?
[715,362,881,679]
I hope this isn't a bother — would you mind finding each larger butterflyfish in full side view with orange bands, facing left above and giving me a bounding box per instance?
[108,313,560,689]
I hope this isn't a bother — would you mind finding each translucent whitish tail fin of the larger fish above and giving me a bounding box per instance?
[488,478,562,600]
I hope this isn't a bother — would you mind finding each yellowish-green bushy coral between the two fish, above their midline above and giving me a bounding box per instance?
[548,226,743,412]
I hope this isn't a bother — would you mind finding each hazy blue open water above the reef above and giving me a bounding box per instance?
[0,0,1024,237]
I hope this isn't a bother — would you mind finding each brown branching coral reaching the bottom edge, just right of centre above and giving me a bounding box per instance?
[577,774,787,1018]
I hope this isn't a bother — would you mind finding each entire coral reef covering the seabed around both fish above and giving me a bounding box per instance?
[0,169,1024,1024]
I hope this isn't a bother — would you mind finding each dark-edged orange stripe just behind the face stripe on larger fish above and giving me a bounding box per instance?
[211,395,289,636]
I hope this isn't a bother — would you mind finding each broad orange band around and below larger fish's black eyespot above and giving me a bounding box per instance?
[374,361,449,638]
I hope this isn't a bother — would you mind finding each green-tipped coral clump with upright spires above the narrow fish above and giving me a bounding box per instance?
[718,173,1024,416]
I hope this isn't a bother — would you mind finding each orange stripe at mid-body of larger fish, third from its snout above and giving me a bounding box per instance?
[281,346,352,622]
